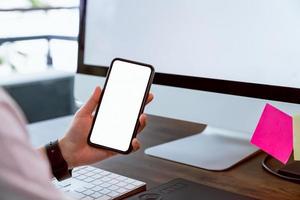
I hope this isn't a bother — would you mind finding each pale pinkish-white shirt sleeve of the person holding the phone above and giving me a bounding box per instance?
[0,89,68,200]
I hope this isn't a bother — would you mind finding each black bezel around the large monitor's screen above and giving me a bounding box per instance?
[77,0,300,103]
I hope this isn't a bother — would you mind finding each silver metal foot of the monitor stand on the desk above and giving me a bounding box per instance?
[145,126,258,171]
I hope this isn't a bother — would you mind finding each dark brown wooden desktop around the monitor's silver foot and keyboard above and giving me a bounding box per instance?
[28,116,300,200]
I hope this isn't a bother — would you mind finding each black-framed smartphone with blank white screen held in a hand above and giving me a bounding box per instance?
[88,58,154,154]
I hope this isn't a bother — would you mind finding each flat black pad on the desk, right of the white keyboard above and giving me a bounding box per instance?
[129,178,255,200]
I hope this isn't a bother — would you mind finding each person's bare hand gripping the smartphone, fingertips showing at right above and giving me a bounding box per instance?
[59,87,153,169]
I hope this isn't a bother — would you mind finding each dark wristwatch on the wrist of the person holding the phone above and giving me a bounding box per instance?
[46,140,72,181]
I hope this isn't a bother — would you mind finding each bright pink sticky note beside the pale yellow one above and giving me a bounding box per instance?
[251,104,293,164]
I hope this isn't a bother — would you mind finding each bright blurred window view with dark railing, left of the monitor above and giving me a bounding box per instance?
[0,0,79,76]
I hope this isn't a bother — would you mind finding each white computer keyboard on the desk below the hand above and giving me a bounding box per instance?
[52,166,146,200]
